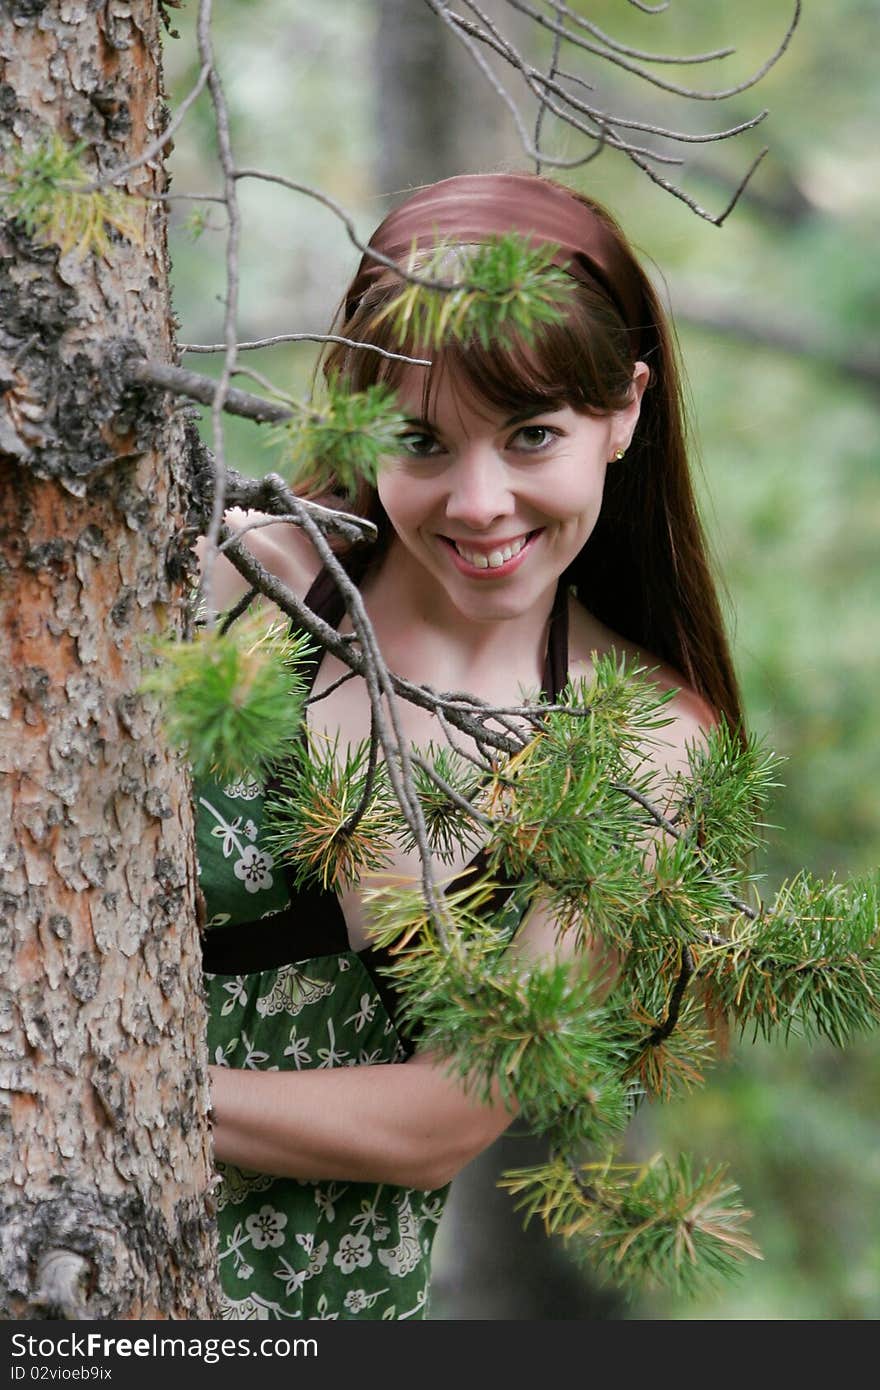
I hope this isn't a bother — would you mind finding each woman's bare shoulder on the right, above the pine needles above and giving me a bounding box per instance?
[569,602,717,774]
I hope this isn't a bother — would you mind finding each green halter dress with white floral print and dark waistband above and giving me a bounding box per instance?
[196,780,446,1319]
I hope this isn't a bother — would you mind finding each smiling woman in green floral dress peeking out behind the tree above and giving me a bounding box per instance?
[199,174,740,1318]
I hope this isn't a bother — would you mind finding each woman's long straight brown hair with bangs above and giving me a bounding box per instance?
[304,181,744,730]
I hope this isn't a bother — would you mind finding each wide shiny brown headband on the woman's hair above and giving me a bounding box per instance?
[346,174,646,352]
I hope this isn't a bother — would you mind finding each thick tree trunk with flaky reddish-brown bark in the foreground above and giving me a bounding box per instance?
[0,0,215,1319]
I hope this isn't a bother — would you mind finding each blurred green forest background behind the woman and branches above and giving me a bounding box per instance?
[165,0,880,1319]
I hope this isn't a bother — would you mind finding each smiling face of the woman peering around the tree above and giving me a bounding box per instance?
[378,363,648,621]
